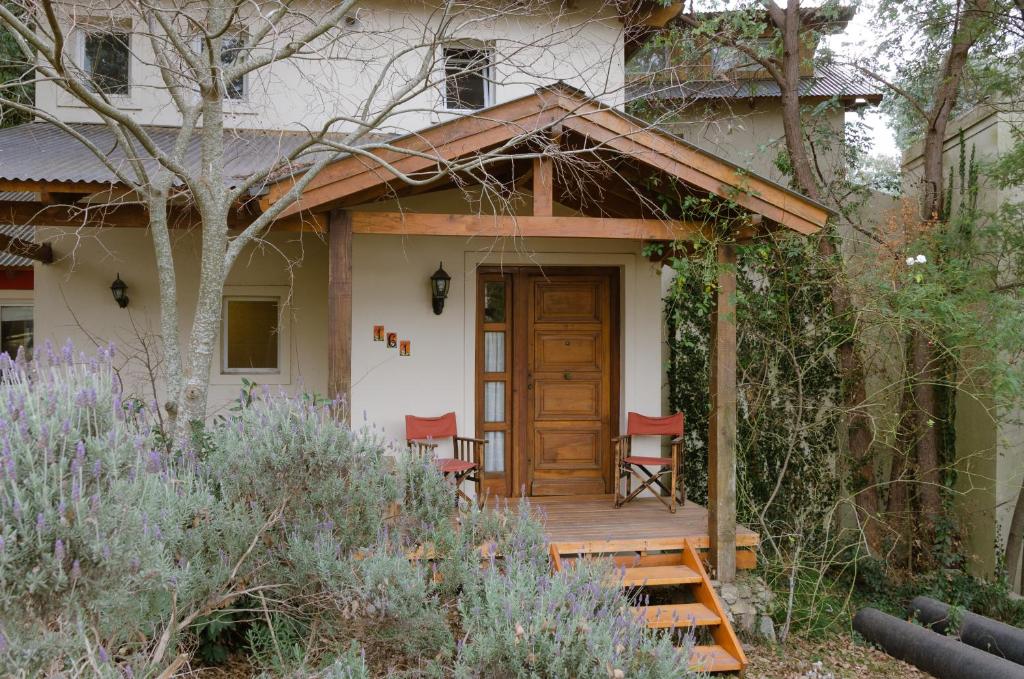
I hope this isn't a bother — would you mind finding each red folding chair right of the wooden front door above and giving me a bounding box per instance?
[611,413,686,514]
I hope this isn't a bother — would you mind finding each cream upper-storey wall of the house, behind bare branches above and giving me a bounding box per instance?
[36,0,624,132]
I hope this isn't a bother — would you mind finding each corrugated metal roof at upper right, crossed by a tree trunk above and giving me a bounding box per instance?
[626,66,882,103]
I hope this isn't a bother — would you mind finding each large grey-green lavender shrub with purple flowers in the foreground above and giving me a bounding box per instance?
[0,347,685,679]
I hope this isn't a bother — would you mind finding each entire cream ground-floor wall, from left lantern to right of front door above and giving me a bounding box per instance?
[29,228,663,454]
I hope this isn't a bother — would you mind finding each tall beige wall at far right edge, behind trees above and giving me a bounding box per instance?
[903,107,1024,590]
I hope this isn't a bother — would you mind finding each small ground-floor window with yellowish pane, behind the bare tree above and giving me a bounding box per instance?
[221,297,281,373]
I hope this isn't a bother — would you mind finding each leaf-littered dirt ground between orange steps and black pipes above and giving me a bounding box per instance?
[746,637,932,679]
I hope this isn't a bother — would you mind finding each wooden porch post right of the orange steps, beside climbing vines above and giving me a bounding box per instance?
[708,243,736,583]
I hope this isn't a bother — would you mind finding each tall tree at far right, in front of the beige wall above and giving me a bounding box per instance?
[859,0,1012,538]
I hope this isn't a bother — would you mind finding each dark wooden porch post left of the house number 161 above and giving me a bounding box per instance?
[327,210,352,419]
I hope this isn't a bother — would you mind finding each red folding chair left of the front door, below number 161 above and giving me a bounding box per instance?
[406,413,487,504]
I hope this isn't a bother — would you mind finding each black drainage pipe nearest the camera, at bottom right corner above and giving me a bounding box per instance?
[853,608,1024,679]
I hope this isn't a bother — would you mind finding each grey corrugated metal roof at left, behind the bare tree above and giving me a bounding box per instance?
[0,123,372,190]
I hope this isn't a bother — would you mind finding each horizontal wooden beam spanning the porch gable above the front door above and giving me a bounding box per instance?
[351,212,707,241]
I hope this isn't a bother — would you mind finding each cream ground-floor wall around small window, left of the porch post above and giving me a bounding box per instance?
[35,227,327,412]
